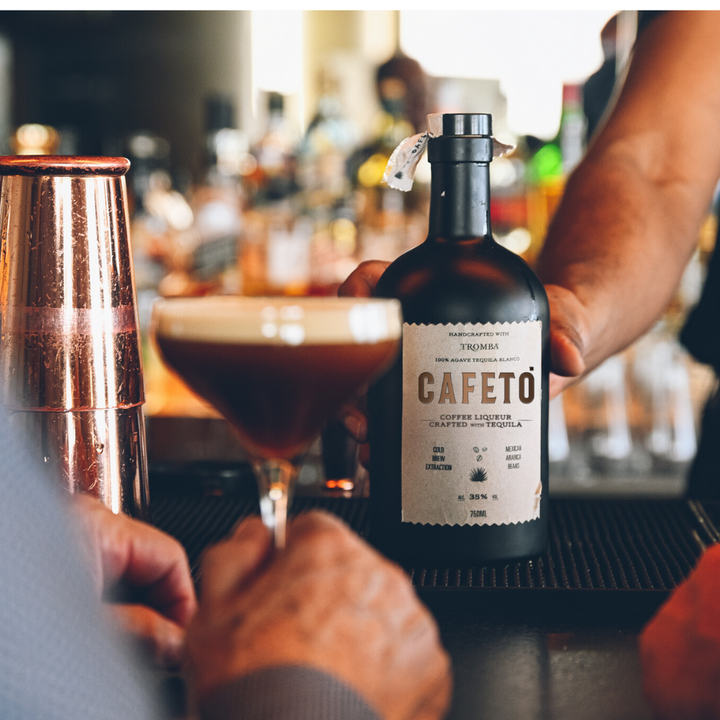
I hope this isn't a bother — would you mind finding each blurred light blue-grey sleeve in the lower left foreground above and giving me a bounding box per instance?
[0,408,160,720]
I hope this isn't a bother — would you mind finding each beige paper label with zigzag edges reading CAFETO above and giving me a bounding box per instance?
[402,320,542,525]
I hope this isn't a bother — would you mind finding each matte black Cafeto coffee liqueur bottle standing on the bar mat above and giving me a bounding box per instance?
[369,114,550,567]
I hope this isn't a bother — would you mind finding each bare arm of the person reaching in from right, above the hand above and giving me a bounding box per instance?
[538,12,720,374]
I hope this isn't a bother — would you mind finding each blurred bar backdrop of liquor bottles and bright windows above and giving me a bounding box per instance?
[0,10,717,490]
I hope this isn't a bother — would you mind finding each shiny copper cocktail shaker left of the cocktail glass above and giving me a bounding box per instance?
[0,156,148,517]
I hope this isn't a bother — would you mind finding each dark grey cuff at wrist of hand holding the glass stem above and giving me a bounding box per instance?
[200,665,380,720]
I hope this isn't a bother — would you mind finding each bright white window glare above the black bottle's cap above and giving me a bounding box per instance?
[400,10,616,139]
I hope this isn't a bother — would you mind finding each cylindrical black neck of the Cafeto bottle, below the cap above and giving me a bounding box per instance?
[429,162,492,240]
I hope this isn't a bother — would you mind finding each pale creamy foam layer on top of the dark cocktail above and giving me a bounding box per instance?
[153,297,402,345]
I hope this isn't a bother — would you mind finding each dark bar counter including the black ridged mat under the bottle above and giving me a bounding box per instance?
[146,416,704,720]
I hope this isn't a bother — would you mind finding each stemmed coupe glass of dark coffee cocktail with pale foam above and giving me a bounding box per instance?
[152,296,402,548]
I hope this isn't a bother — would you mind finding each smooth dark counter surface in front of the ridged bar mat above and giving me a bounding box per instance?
[435,598,652,720]
